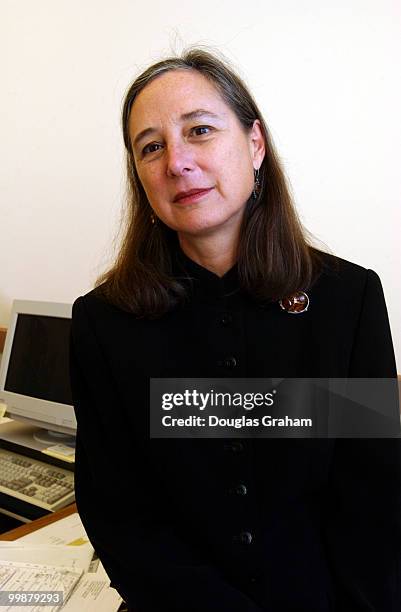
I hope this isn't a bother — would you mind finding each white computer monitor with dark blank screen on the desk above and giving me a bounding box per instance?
[0,300,77,445]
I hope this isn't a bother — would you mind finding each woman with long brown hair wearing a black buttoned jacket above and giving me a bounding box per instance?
[71,49,401,612]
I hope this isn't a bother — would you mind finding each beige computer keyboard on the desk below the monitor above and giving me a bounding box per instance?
[0,448,75,512]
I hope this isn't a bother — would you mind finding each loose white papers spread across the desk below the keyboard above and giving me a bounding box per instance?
[0,513,122,612]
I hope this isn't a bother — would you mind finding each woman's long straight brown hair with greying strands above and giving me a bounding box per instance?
[95,48,328,318]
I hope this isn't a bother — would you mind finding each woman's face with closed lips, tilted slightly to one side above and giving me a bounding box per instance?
[129,70,264,238]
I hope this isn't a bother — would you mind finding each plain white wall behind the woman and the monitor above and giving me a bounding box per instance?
[0,0,401,370]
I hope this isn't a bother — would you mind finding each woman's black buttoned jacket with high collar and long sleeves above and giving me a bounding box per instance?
[71,254,401,612]
